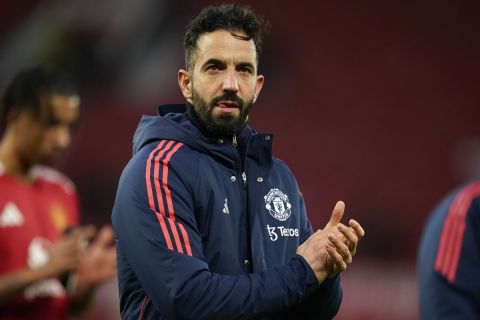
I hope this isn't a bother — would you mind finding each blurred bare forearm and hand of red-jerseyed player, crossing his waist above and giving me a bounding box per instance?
[0,228,94,305]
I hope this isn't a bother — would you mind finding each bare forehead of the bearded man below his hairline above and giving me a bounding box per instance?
[197,30,257,65]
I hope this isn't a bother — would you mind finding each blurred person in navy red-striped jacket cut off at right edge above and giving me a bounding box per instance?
[417,181,480,320]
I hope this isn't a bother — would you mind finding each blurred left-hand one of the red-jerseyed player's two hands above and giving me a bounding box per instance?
[41,226,95,278]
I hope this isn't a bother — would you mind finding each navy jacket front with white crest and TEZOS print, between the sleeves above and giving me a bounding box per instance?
[191,158,301,273]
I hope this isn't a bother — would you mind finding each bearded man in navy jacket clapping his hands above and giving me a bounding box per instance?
[112,5,364,319]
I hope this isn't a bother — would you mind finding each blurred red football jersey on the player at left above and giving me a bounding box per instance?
[0,166,78,320]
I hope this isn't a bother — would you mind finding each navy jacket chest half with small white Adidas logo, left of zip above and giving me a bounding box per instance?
[194,166,249,274]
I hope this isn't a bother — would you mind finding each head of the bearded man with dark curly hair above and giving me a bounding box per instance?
[178,5,264,136]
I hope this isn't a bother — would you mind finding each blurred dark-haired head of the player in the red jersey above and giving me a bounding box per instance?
[0,67,80,167]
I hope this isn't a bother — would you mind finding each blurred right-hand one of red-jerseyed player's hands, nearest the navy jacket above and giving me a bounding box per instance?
[78,226,117,286]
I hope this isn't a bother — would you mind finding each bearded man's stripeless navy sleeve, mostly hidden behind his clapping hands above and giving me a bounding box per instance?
[282,194,343,320]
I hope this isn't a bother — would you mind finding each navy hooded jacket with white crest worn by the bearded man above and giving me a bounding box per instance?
[112,105,342,319]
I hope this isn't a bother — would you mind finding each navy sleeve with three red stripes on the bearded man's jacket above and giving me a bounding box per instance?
[112,143,319,319]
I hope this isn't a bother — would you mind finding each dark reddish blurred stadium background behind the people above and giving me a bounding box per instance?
[0,0,480,319]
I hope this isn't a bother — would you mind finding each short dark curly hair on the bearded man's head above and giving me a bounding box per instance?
[183,4,267,71]
